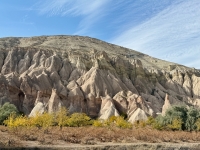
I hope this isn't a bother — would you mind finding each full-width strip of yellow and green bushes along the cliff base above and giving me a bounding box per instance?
[0,103,200,131]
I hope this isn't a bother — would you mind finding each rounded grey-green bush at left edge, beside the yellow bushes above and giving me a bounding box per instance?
[0,102,19,124]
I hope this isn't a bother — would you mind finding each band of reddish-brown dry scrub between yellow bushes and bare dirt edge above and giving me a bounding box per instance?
[0,126,200,145]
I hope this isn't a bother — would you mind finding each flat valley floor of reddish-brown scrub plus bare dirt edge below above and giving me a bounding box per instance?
[0,126,200,150]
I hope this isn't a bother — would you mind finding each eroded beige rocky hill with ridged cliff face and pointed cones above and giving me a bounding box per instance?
[0,36,200,122]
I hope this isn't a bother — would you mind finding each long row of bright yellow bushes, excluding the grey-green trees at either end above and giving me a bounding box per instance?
[3,103,133,130]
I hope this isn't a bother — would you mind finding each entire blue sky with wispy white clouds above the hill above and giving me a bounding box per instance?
[0,0,200,69]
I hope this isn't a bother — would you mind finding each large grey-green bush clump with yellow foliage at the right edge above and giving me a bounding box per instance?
[146,106,200,131]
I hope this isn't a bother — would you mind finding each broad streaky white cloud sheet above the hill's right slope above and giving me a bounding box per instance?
[111,0,200,68]
